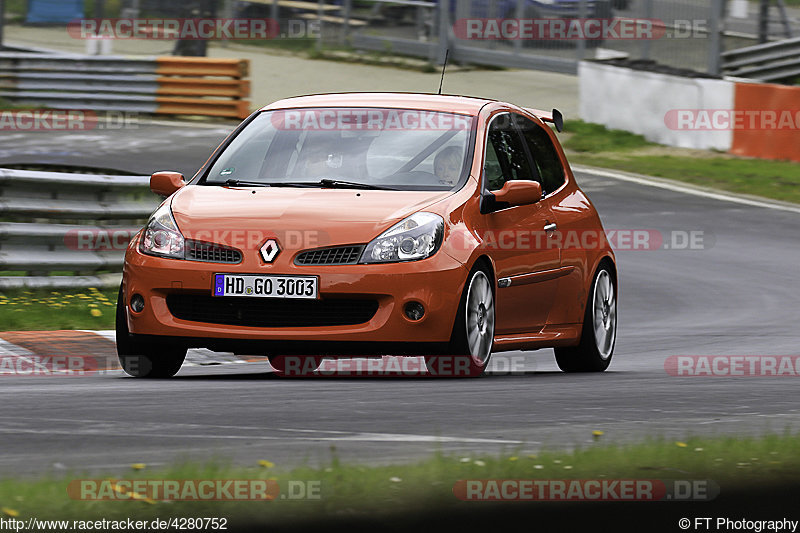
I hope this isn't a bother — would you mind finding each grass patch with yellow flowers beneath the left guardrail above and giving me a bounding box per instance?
[0,288,117,331]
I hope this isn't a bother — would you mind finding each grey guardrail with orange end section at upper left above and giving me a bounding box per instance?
[0,52,250,119]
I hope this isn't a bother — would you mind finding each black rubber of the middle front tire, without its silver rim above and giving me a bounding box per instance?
[425,265,495,377]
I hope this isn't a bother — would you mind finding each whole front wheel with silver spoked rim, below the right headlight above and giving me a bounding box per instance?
[425,267,495,377]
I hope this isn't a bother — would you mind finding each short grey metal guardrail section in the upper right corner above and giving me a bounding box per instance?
[722,37,800,81]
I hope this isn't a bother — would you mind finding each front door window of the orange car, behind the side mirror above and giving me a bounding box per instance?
[484,113,535,191]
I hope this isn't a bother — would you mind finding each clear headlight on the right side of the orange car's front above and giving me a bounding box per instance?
[361,212,444,263]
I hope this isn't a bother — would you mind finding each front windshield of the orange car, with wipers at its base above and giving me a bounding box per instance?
[201,108,473,190]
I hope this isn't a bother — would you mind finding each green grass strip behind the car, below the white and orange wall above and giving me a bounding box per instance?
[564,120,800,203]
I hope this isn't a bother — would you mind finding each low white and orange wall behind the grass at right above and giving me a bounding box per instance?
[578,61,800,161]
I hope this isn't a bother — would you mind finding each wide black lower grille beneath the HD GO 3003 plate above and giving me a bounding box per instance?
[167,294,378,328]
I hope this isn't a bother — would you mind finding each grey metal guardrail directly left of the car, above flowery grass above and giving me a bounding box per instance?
[0,168,160,289]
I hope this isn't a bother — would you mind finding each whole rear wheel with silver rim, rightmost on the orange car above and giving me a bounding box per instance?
[555,265,617,372]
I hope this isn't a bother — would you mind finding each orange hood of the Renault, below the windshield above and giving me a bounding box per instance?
[171,185,452,249]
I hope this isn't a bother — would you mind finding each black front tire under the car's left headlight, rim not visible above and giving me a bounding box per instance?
[116,285,186,378]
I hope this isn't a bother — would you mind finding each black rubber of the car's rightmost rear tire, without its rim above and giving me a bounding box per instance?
[554,264,617,372]
